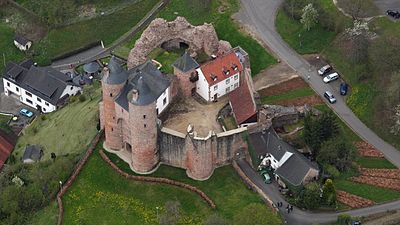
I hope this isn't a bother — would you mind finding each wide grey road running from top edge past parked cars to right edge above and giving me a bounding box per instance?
[239,0,400,168]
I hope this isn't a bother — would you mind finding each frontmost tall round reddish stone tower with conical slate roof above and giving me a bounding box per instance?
[127,77,159,174]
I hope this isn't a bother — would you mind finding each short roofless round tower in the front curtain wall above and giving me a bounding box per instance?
[185,127,214,180]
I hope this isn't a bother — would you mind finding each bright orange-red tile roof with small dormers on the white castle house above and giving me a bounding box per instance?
[200,51,243,86]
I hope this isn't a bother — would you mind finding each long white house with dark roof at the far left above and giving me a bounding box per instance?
[3,60,81,113]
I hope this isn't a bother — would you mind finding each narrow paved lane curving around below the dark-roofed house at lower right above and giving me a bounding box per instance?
[237,159,400,225]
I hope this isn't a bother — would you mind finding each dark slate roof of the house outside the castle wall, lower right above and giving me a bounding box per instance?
[250,128,318,186]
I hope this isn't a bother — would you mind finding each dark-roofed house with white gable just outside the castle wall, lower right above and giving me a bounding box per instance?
[250,127,319,186]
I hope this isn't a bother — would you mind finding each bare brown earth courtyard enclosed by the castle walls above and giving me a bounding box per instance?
[163,95,229,137]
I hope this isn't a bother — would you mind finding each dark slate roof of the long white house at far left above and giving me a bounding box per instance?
[4,62,76,105]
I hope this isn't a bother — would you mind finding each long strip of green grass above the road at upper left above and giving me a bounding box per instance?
[33,0,158,64]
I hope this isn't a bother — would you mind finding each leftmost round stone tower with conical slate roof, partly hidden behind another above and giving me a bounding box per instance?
[102,57,128,150]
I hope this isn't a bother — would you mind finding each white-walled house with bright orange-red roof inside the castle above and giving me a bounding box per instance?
[196,51,243,101]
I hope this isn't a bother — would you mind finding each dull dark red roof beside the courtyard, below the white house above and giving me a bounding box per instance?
[229,79,257,125]
